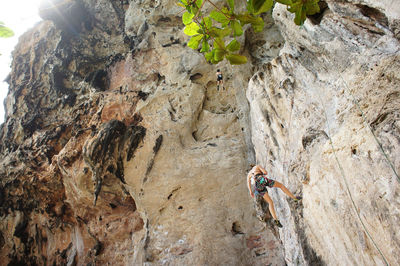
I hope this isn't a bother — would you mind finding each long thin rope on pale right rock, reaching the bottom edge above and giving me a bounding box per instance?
[309,61,389,265]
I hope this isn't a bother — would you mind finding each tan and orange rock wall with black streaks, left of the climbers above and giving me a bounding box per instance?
[0,1,284,265]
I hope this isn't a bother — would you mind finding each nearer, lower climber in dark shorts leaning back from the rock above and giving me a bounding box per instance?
[247,165,301,227]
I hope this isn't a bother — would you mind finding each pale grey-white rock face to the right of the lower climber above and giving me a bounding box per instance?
[247,1,400,265]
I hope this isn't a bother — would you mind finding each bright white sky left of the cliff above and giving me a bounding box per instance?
[0,0,41,123]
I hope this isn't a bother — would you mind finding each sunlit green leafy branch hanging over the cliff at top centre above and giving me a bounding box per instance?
[178,0,320,65]
